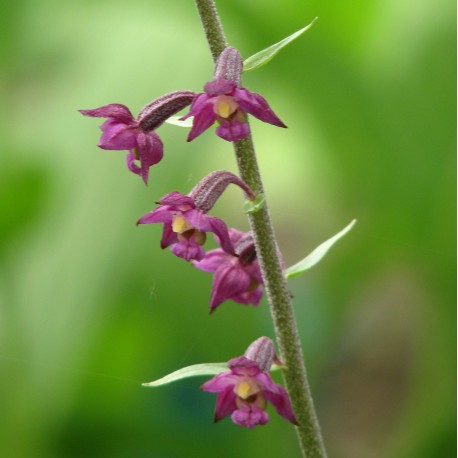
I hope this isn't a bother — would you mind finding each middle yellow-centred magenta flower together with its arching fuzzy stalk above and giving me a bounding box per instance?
[137,170,254,261]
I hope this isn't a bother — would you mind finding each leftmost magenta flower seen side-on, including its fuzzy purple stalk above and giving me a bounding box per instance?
[79,91,196,184]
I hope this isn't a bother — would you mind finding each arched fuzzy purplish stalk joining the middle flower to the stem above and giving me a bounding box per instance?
[189,170,255,213]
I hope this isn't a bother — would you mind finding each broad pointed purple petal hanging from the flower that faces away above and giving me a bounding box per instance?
[210,258,251,311]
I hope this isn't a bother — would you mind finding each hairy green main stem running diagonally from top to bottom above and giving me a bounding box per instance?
[196,0,326,458]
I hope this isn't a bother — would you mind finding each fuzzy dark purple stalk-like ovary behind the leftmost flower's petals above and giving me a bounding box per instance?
[137,91,196,132]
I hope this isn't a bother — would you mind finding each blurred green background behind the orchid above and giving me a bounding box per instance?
[0,0,456,458]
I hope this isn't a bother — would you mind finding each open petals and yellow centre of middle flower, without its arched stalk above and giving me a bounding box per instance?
[137,192,233,261]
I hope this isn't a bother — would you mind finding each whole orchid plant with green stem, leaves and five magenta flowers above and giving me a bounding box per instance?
[80,4,354,457]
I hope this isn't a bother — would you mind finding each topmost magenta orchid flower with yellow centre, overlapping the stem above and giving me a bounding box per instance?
[181,47,286,142]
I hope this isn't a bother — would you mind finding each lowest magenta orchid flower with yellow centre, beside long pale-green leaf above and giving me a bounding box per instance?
[202,337,297,428]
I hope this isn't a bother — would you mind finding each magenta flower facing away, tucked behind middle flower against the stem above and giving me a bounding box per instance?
[193,229,262,312]
